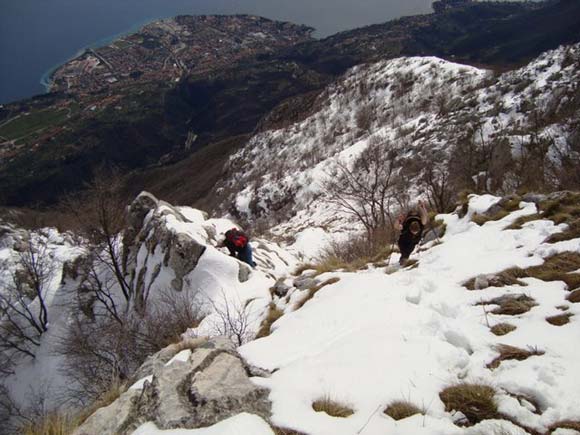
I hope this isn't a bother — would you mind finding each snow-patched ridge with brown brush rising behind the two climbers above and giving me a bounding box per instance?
[214,44,580,233]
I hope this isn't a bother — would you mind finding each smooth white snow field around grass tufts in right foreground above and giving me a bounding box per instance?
[234,195,580,435]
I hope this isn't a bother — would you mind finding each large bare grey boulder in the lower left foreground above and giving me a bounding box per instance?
[74,337,271,435]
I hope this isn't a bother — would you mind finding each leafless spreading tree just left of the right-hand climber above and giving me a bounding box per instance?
[323,140,400,241]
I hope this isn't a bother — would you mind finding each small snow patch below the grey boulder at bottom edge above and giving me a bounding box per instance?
[132,412,274,435]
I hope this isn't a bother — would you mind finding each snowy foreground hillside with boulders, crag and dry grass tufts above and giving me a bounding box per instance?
[0,189,580,435]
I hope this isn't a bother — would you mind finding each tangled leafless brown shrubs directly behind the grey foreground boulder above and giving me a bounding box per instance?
[57,290,201,404]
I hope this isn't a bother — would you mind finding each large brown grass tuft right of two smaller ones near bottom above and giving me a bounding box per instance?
[439,383,498,424]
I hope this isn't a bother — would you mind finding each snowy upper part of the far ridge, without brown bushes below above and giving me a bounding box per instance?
[218,45,580,245]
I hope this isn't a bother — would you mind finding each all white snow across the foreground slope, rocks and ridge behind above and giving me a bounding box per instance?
[0,45,580,435]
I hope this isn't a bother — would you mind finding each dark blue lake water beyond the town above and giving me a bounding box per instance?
[0,0,432,103]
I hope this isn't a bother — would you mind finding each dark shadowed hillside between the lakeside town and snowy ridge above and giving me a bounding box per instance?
[0,2,580,206]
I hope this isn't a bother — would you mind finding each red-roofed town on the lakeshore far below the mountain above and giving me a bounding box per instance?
[50,15,313,96]
